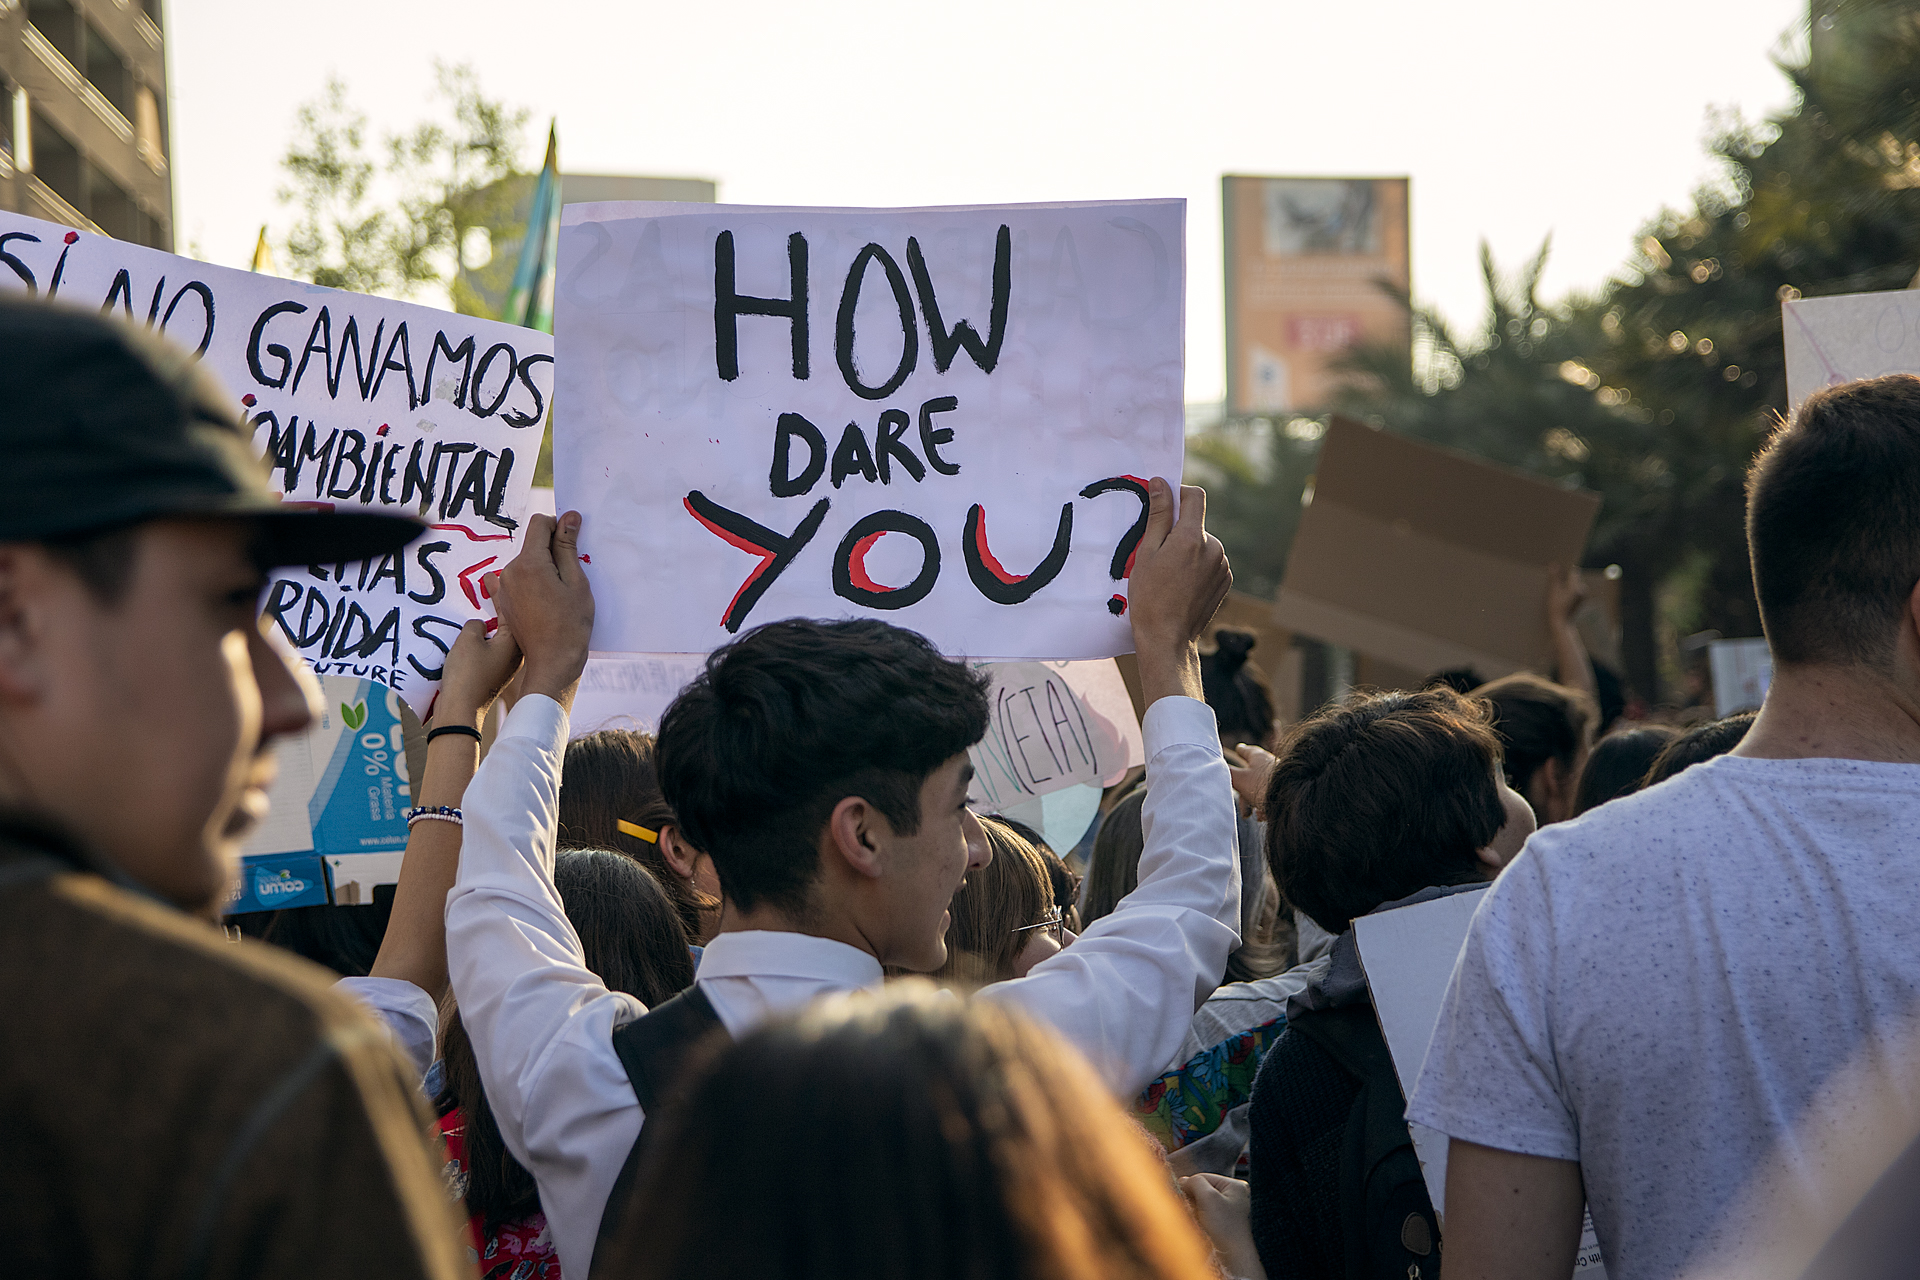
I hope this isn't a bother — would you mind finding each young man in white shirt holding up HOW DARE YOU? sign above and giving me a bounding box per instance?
[447,480,1240,1276]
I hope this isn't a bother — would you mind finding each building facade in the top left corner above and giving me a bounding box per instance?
[0,0,173,249]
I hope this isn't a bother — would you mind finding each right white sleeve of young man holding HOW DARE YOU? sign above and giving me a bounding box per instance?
[979,697,1240,1098]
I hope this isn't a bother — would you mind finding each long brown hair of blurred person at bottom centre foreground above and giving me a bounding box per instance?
[607,983,1215,1280]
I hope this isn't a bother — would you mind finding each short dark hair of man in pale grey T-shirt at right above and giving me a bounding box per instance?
[1747,374,1920,666]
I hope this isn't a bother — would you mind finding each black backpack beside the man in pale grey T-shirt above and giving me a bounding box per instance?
[1286,1004,1440,1280]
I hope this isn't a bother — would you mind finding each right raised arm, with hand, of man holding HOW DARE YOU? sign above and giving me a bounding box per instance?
[981,480,1240,1098]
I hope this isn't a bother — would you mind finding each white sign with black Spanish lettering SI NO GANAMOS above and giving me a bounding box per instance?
[0,213,553,714]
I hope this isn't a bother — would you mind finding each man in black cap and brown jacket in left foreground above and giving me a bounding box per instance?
[0,297,465,1276]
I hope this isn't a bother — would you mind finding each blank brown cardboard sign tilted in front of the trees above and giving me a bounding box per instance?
[1273,416,1599,679]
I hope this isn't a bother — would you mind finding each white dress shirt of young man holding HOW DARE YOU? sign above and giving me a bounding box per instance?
[447,695,1240,1280]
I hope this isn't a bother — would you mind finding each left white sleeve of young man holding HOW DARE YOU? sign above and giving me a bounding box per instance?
[447,695,645,1276]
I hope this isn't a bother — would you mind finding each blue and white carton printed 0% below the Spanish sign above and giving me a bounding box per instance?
[228,676,413,913]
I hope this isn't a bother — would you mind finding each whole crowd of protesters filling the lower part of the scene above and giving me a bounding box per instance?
[11,289,1920,1280]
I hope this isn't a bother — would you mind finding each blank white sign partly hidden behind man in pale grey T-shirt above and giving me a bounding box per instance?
[1354,890,1607,1280]
